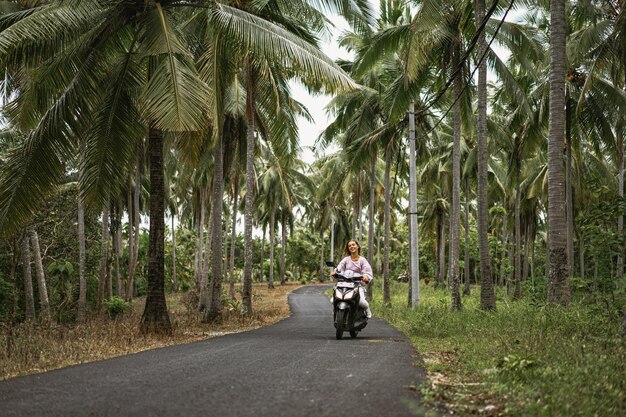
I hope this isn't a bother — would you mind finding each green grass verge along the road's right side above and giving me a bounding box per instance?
[372,282,626,417]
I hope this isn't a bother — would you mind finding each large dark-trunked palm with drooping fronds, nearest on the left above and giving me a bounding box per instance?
[0,1,208,332]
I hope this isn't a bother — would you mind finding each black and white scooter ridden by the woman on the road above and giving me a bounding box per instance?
[326,262,367,339]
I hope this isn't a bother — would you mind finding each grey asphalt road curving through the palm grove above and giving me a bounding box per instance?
[0,286,424,417]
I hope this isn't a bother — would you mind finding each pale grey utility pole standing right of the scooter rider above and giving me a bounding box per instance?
[409,100,420,307]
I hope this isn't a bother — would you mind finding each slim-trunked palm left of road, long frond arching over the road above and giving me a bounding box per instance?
[207,1,355,314]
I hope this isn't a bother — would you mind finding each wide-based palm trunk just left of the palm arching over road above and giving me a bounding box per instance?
[204,134,224,323]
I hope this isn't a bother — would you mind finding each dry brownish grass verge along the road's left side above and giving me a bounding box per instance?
[0,283,301,380]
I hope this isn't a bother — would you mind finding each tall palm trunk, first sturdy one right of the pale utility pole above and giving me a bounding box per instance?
[449,34,463,310]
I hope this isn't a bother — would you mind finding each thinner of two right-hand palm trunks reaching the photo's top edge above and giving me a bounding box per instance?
[476,0,496,310]
